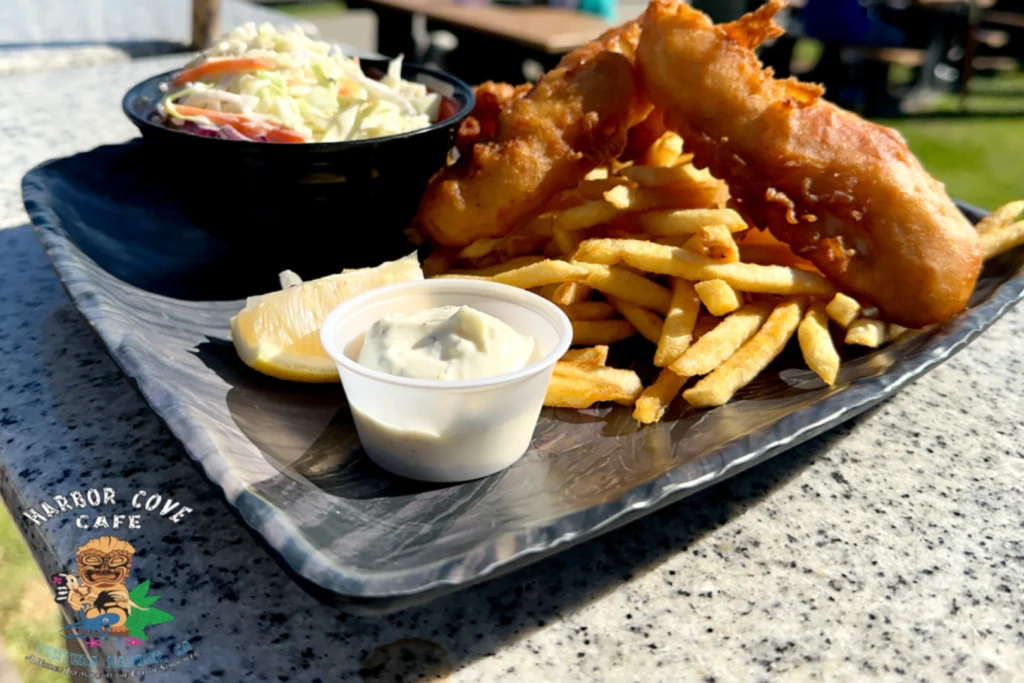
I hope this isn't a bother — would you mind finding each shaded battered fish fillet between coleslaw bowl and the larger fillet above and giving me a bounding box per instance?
[416,22,650,247]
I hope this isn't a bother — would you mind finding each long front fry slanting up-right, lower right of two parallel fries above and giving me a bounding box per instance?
[683,297,807,408]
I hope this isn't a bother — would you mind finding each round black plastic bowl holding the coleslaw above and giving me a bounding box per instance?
[122,59,474,279]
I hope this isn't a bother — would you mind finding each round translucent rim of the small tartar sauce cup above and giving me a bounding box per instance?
[319,278,572,391]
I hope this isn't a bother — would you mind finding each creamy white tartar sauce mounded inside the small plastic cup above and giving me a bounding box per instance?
[358,306,537,380]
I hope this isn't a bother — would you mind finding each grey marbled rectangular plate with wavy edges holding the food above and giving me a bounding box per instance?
[23,142,1024,611]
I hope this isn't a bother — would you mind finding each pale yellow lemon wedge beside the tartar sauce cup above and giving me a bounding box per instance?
[231,253,423,383]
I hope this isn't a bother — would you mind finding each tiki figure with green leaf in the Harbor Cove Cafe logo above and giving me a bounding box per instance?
[51,536,174,644]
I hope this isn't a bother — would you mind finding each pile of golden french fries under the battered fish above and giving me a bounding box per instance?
[415,133,1024,424]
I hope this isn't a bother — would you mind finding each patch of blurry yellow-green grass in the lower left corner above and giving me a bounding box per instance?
[0,504,71,683]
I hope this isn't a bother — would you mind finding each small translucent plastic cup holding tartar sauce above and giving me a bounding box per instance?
[321,279,572,482]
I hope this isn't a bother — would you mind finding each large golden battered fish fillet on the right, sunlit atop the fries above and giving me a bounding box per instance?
[637,0,982,328]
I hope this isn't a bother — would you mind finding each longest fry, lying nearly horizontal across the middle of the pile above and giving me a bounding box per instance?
[575,239,836,297]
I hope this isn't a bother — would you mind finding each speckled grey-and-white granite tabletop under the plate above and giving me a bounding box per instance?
[0,58,1024,683]
